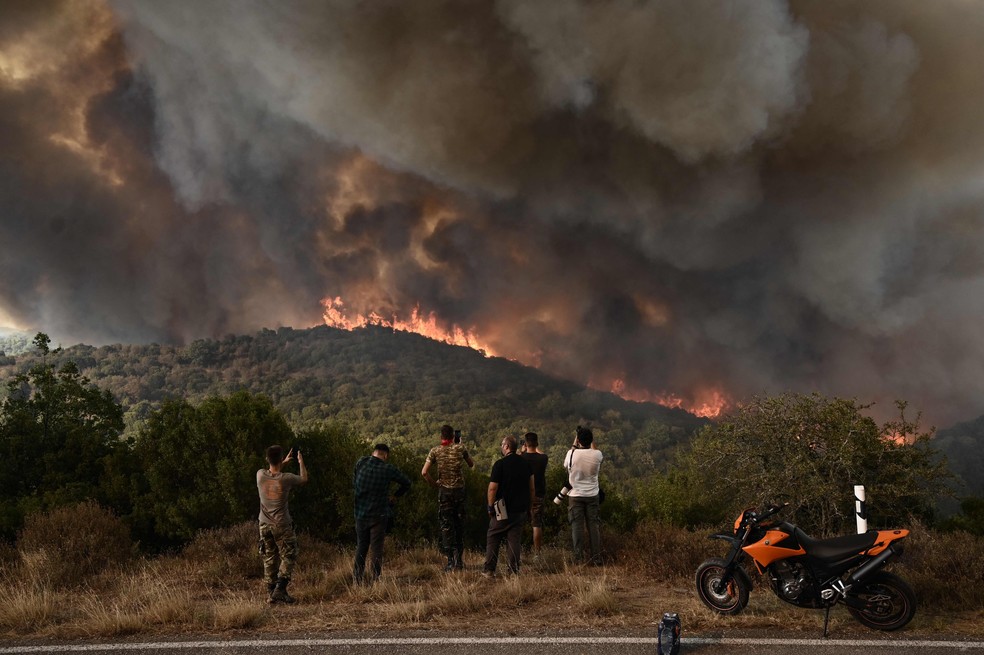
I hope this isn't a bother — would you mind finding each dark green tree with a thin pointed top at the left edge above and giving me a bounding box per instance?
[0,332,123,537]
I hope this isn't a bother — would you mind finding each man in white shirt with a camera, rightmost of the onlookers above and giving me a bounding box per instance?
[564,426,603,566]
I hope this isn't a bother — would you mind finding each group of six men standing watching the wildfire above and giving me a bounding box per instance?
[256,425,603,603]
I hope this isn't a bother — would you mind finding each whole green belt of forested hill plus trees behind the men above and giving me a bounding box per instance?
[0,327,979,550]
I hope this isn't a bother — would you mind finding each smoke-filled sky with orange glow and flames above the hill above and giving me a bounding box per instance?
[0,0,984,425]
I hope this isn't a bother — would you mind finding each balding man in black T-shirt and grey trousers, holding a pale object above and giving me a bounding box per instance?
[482,436,535,577]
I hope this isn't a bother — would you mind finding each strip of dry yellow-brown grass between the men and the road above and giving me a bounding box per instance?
[0,524,984,639]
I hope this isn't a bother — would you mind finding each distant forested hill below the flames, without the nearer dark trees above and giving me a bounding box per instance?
[0,327,706,477]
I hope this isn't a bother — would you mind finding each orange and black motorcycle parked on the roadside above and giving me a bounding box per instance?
[696,503,916,636]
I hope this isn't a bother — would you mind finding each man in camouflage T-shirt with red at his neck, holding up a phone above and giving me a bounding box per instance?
[420,425,475,571]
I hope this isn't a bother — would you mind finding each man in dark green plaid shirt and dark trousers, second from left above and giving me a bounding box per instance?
[352,443,410,584]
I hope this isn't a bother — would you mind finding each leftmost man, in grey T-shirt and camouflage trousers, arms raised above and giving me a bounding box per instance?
[256,446,308,603]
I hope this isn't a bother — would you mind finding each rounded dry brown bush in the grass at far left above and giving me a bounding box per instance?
[17,500,135,587]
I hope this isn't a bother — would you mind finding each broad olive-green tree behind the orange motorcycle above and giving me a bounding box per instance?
[676,394,952,536]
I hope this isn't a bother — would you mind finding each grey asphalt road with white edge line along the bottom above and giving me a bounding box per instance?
[0,633,984,655]
